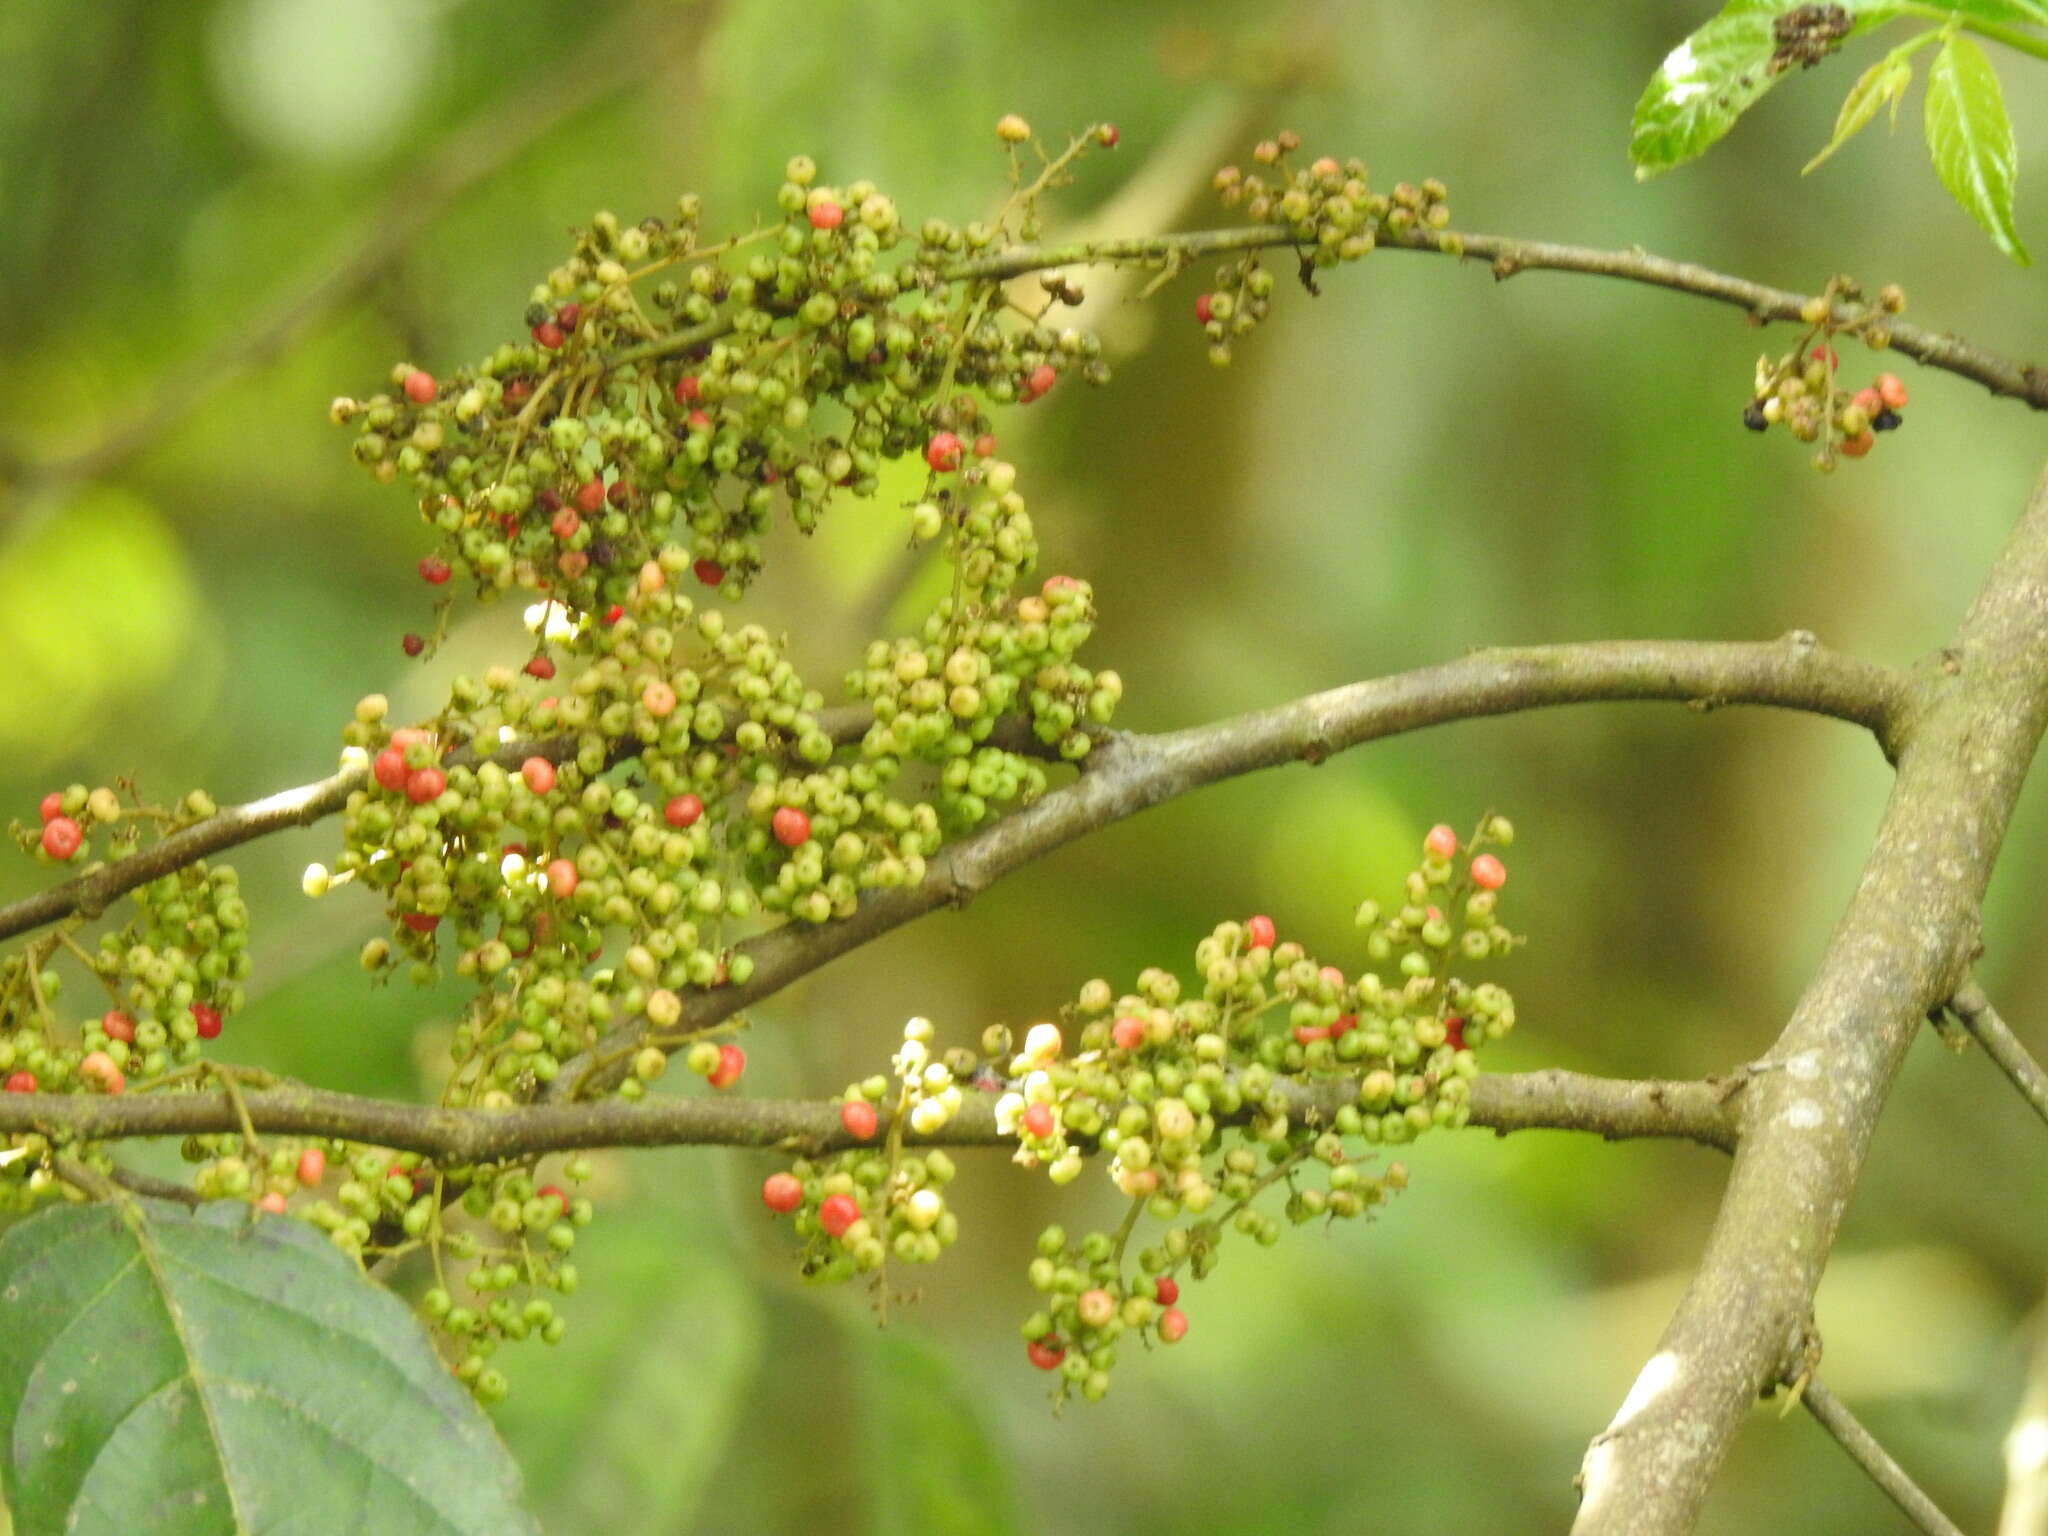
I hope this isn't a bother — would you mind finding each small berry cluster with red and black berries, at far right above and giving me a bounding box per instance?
[1743,279,1907,469]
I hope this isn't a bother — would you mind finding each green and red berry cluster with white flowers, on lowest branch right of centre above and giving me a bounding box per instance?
[762,817,1520,1401]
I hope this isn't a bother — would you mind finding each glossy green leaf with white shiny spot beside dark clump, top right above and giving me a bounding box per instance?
[1628,0,1901,180]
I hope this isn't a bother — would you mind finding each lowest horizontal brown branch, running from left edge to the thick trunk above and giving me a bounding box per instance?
[0,1071,1737,1165]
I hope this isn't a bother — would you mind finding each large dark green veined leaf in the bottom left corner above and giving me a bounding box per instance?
[0,1200,539,1536]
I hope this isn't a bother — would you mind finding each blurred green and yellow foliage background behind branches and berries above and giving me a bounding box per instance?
[0,0,2048,1536]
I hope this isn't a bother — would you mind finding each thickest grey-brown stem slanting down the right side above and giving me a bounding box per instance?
[1575,462,2048,1536]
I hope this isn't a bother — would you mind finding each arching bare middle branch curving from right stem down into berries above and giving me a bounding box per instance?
[549,631,1909,1098]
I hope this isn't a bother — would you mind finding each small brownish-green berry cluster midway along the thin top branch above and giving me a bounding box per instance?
[1194,133,1462,367]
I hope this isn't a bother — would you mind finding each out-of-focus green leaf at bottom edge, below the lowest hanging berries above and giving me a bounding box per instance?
[866,1325,1018,1536]
